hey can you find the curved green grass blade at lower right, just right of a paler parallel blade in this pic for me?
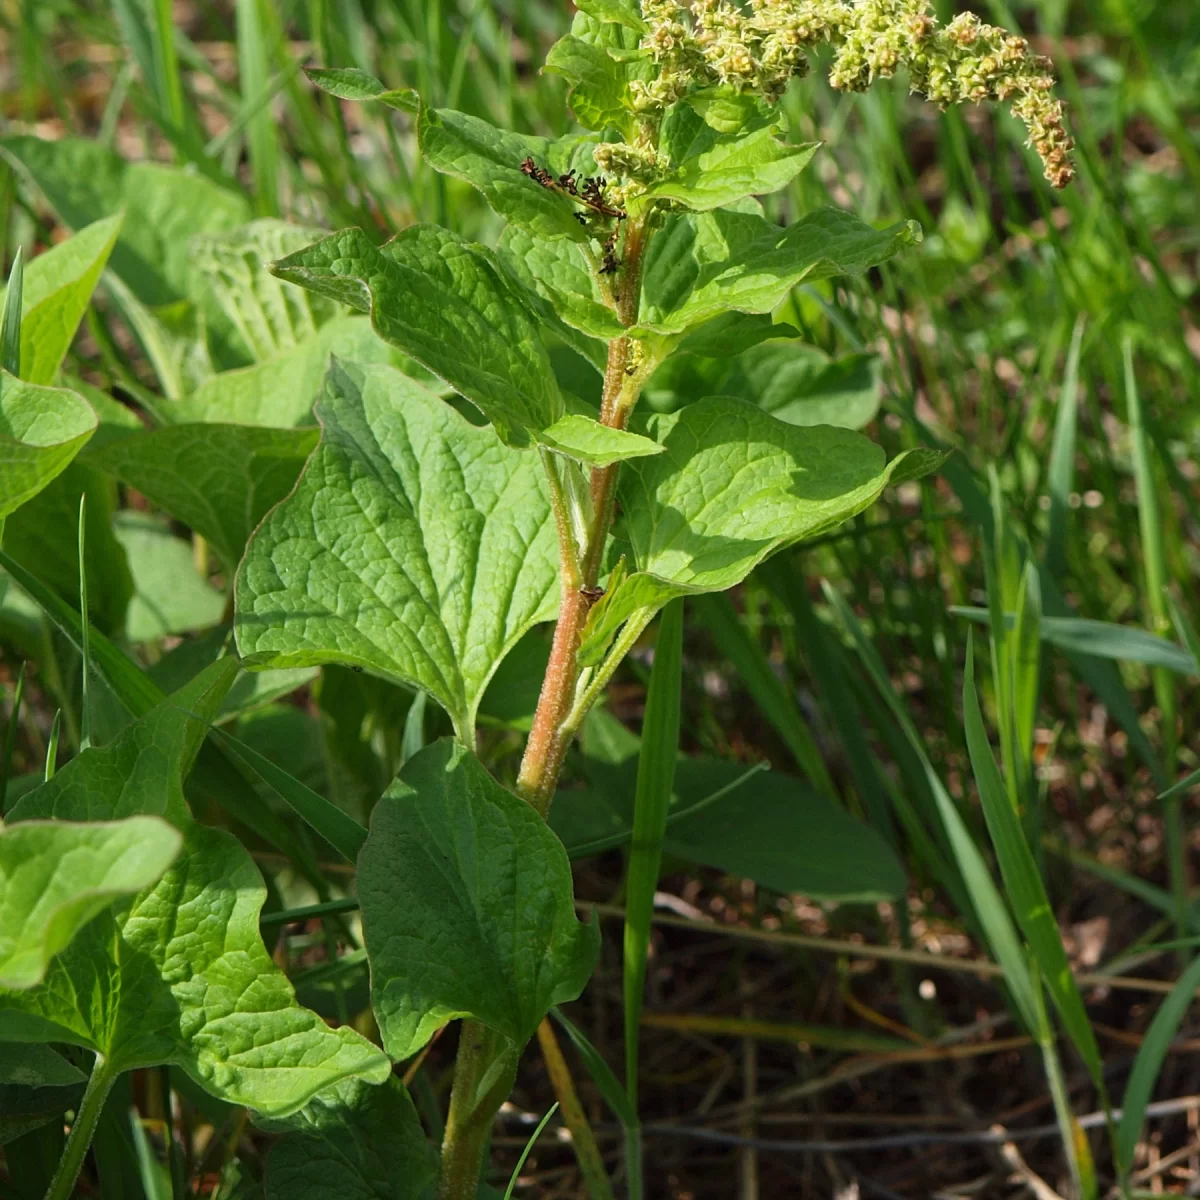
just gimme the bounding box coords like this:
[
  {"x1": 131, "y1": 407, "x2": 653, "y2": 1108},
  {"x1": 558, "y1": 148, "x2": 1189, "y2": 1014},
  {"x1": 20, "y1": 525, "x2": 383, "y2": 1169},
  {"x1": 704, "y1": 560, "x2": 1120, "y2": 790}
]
[{"x1": 962, "y1": 643, "x2": 1103, "y2": 1085}]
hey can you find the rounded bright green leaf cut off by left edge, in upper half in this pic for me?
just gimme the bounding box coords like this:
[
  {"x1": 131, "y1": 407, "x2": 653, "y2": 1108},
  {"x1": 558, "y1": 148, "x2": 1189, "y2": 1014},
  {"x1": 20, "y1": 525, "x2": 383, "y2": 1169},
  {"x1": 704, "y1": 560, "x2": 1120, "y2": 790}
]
[{"x1": 0, "y1": 371, "x2": 97, "y2": 521}]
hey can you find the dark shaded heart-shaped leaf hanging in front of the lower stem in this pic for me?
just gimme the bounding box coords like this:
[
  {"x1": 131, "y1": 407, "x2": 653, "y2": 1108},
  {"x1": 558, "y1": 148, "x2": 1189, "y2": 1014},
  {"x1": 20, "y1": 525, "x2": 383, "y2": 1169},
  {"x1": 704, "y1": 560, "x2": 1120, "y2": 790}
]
[{"x1": 359, "y1": 740, "x2": 600, "y2": 1060}]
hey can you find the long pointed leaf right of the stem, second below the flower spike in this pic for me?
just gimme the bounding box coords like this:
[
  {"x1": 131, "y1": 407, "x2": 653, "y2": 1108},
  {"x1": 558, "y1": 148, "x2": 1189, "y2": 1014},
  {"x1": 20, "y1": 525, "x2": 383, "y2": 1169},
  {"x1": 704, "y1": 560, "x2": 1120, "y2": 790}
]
[{"x1": 640, "y1": 209, "x2": 920, "y2": 334}]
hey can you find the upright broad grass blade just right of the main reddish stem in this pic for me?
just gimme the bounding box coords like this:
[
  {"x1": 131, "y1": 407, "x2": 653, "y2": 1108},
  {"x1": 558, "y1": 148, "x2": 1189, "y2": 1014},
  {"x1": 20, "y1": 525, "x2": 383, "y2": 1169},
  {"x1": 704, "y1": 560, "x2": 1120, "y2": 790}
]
[{"x1": 624, "y1": 600, "x2": 683, "y2": 1106}]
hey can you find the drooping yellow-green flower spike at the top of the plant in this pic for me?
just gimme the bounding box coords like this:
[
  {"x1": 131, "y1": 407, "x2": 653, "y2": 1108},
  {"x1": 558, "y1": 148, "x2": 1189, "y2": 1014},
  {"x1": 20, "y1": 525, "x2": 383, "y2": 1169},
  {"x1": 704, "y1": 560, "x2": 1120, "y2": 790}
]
[{"x1": 635, "y1": 0, "x2": 1074, "y2": 187}]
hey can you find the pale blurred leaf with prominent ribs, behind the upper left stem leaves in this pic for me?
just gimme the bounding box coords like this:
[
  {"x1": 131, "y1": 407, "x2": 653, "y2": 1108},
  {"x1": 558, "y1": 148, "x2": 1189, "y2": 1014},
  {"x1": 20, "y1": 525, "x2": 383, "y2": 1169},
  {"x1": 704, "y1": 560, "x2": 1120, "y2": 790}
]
[{"x1": 192, "y1": 221, "x2": 342, "y2": 362}]
